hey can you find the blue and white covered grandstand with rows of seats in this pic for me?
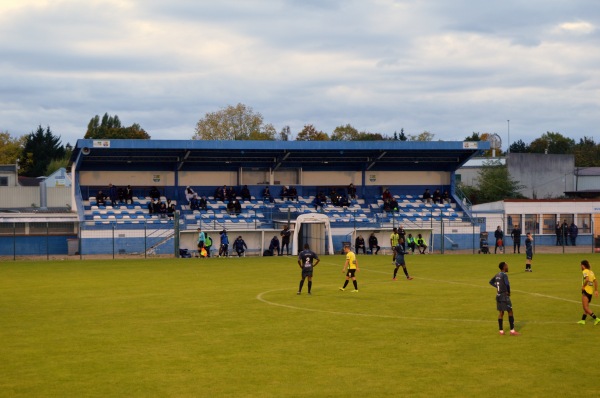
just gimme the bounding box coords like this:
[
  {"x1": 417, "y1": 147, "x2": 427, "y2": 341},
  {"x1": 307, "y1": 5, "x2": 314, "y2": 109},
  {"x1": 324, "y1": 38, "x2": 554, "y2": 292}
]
[{"x1": 58, "y1": 140, "x2": 489, "y2": 254}]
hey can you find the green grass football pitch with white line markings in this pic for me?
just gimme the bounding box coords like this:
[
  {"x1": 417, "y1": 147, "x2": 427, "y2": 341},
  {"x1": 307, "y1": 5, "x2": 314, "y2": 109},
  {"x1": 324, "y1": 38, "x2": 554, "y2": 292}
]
[{"x1": 0, "y1": 254, "x2": 600, "y2": 397}]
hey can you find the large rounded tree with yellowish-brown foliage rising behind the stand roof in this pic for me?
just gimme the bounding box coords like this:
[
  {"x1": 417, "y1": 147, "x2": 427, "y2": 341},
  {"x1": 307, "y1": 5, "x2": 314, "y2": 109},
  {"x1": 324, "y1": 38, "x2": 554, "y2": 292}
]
[{"x1": 192, "y1": 103, "x2": 268, "y2": 140}]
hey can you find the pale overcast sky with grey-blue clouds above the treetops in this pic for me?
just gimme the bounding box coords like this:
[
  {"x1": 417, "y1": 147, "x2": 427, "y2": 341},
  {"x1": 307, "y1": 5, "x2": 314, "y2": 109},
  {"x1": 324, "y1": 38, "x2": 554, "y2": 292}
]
[{"x1": 0, "y1": 0, "x2": 600, "y2": 148}]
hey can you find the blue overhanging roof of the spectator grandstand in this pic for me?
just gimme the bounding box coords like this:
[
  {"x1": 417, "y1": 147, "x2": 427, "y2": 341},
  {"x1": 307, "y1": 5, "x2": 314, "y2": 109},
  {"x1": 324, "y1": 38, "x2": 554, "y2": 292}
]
[{"x1": 72, "y1": 139, "x2": 490, "y2": 171}]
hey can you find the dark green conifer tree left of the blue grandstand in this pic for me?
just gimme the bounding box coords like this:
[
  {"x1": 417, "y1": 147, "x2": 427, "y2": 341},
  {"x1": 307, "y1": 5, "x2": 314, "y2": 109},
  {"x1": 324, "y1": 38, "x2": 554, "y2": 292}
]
[{"x1": 20, "y1": 126, "x2": 65, "y2": 177}]
